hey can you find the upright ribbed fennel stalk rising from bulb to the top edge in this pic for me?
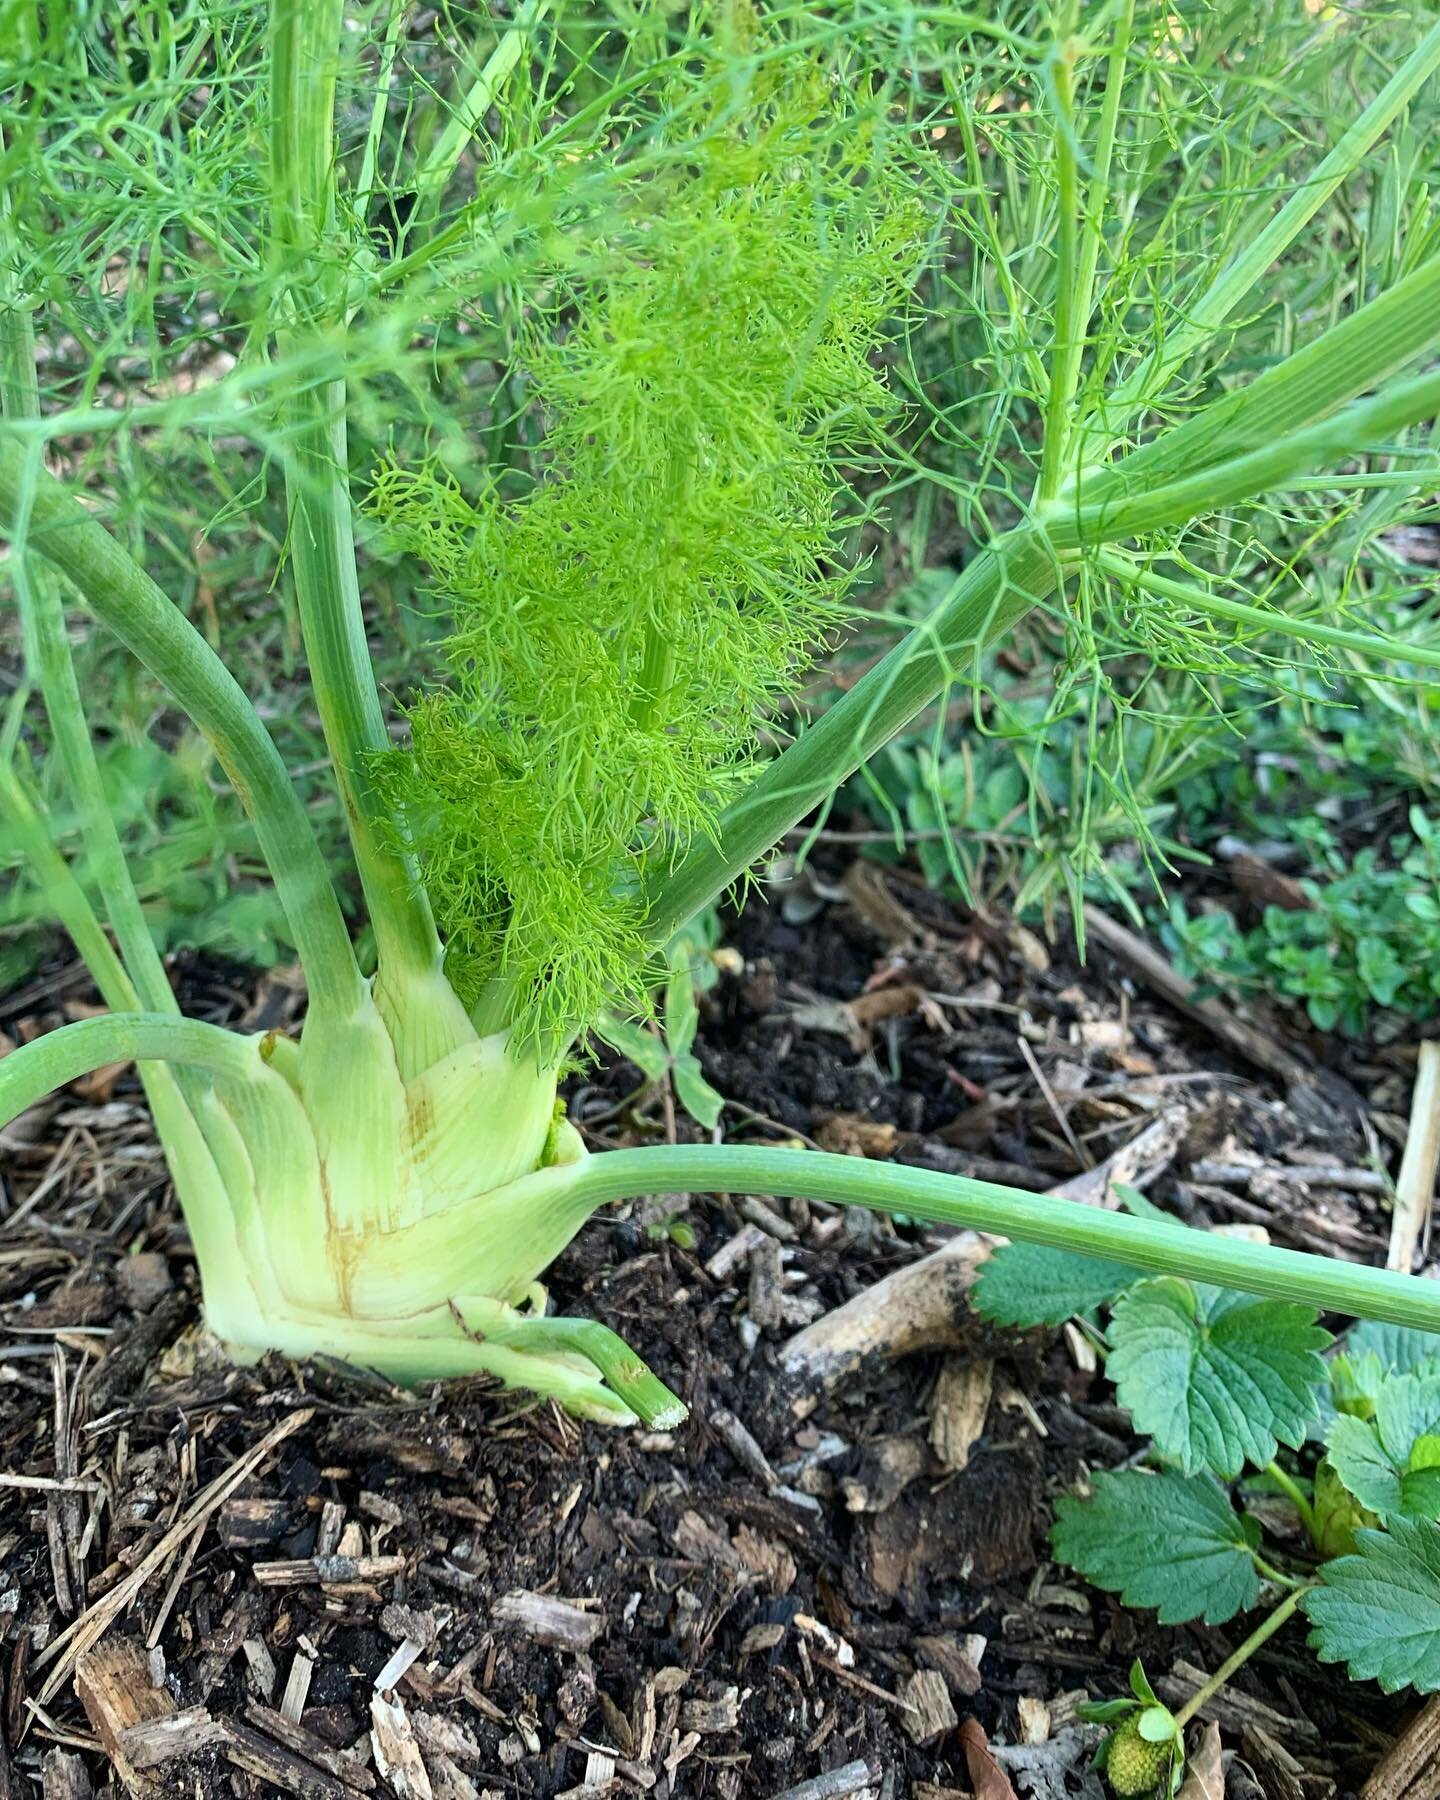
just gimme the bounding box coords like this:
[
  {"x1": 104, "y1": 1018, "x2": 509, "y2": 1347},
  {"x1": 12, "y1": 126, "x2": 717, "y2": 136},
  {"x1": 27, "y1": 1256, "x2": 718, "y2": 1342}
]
[{"x1": 270, "y1": 0, "x2": 441, "y2": 994}]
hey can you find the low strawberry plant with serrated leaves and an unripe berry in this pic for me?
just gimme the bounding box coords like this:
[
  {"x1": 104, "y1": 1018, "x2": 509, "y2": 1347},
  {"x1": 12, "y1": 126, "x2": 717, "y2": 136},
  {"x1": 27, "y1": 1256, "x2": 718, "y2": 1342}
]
[{"x1": 974, "y1": 1224, "x2": 1440, "y2": 1796}]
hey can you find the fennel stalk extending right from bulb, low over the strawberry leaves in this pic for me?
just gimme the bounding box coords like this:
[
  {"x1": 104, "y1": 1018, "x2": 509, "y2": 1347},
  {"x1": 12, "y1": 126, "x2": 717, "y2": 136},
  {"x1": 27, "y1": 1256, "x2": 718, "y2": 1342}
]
[{"x1": 576, "y1": 1145, "x2": 1440, "y2": 1332}]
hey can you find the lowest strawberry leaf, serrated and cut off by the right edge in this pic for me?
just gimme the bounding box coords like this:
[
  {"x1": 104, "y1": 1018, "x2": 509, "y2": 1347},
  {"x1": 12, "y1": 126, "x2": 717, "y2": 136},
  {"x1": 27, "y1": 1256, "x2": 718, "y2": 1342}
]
[{"x1": 1301, "y1": 1519, "x2": 1440, "y2": 1694}]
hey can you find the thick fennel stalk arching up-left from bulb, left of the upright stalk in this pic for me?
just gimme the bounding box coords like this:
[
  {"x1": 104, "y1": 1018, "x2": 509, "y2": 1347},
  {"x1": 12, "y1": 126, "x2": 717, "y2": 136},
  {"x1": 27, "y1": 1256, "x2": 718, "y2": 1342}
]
[{"x1": 0, "y1": 436, "x2": 364, "y2": 1015}]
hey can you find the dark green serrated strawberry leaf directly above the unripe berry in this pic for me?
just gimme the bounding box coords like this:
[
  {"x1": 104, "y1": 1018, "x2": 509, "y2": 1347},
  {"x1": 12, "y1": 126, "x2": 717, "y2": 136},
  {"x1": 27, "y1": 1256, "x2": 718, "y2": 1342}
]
[{"x1": 1049, "y1": 1469, "x2": 1260, "y2": 1625}]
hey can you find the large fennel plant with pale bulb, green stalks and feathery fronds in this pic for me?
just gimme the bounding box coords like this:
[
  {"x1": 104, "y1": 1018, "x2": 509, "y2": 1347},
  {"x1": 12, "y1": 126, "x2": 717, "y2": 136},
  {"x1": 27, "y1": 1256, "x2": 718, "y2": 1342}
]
[{"x1": 0, "y1": 0, "x2": 1440, "y2": 1422}]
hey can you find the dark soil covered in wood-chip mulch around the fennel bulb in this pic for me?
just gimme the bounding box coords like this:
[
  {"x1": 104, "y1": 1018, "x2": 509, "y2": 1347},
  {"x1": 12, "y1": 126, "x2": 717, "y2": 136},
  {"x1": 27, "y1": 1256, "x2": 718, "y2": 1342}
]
[{"x1": 0, "y1": 859, "x2": 1415, "y2": 1800}]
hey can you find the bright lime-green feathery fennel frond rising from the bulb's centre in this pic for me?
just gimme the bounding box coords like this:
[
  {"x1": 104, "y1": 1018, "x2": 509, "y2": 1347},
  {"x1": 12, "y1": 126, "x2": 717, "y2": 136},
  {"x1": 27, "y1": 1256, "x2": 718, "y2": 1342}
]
[{"x1": 367, "y1": 65, "x2": 927, "y2": 1044}]
